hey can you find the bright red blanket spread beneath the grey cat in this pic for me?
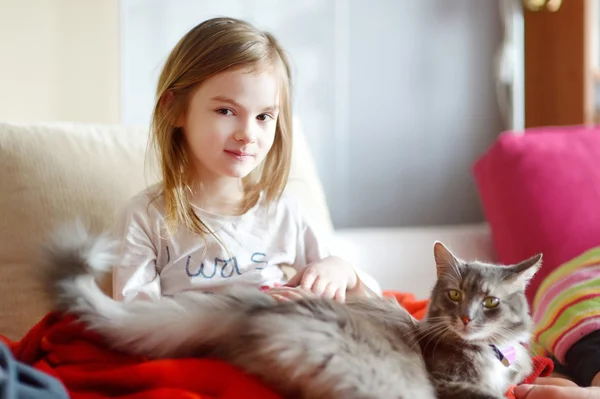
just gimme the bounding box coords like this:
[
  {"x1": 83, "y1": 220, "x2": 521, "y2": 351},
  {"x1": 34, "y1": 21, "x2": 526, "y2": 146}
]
[{"x1": 0, "y1": 292, "x2": 552, "y2": 399}]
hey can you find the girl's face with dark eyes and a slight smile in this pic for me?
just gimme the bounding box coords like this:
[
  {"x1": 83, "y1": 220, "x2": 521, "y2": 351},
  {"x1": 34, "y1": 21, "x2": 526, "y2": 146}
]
[{"x1": 180, "y1": 69, "x2": 279, "y2": 181}]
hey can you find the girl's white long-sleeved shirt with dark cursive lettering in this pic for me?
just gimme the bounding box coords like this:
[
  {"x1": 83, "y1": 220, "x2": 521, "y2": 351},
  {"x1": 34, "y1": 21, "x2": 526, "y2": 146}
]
[{"x1": 113, "y1": 185, "x2": 329, "y2": 300}]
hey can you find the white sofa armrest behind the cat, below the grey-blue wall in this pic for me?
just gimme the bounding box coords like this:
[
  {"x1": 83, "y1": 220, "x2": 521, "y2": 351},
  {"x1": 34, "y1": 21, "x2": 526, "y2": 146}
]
[{"x1": 334, "y1": 223, "x2": 495, "y2": 298}]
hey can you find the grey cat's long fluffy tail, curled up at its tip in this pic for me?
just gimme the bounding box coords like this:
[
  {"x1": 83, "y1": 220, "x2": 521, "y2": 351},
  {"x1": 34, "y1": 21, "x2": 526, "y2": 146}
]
[{"x1": 41, "y1": 223, "x2": 274, "y2": 358}]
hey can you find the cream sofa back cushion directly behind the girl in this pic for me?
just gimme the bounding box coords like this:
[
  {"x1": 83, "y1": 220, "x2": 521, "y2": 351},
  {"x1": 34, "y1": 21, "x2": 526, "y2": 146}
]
[{"x1": 0, "y1": 123, "x2": 333, "y2": 339}]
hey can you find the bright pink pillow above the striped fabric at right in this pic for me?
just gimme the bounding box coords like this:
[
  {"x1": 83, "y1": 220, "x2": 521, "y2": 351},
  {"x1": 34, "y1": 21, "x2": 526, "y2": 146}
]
[{"x1": 473, "y1": 126, "x2": 600, "y2": 302}]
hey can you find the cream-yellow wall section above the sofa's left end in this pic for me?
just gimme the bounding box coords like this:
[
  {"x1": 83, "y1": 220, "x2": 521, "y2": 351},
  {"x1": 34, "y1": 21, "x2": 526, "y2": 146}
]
[{"x1": 0, "y1": 0, "x2": 120, "y2": 123}]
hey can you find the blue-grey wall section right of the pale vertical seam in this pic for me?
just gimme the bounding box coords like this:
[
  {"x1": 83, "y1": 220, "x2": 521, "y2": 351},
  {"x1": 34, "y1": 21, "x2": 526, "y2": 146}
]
[{"x1": 347, "y1": 0, "x2": 502, "y2": 230}]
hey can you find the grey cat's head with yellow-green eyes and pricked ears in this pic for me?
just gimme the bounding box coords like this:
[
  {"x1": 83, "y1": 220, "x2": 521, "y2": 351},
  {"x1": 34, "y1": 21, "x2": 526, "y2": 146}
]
[{"x1": 427, "y1": 242, "x2": 542, "y2": 344}]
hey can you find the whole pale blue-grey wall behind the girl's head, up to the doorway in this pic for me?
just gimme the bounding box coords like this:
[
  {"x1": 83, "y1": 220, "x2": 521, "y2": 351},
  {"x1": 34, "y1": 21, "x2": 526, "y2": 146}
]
[{"x1": 121, "y1": 0, "x2": 503, "y2": 228}]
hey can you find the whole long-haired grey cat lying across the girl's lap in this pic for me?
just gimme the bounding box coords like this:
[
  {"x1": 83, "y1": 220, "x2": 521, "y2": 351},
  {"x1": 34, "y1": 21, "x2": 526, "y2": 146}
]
[{"x1": 43, "y1": 225, "x2": 541, "y2": 399}]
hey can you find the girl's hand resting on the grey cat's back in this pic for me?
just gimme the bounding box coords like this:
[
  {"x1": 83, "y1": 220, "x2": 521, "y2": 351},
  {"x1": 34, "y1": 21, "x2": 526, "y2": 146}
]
[{"x1": 286, "y1": 256, "x2": 358, "y2": 303}]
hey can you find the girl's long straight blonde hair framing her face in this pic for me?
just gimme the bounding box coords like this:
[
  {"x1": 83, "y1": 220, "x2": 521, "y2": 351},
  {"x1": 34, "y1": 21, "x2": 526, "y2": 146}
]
[{"x1": 151, "y1": 18, "x2": 292, "y2": 241}]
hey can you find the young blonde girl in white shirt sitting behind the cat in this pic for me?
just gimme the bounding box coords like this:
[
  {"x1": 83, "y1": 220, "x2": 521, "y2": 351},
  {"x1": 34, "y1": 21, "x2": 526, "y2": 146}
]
[{"x1": 113, "y1": 18, "x2": 366, "y2": 301}]
